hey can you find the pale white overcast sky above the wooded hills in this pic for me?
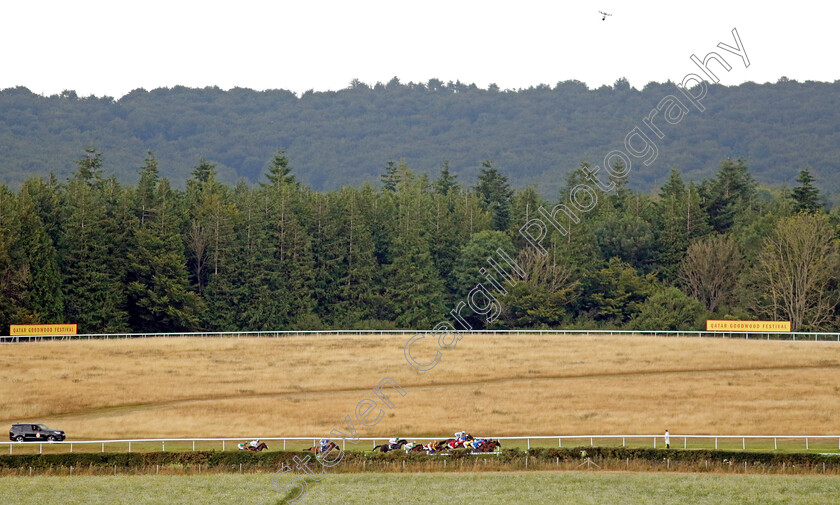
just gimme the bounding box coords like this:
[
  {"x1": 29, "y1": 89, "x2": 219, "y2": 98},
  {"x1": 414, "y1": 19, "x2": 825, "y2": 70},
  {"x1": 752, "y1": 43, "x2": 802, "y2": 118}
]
[{"x1": 0, "y1": 0, "x2": 840, "y2": 97}]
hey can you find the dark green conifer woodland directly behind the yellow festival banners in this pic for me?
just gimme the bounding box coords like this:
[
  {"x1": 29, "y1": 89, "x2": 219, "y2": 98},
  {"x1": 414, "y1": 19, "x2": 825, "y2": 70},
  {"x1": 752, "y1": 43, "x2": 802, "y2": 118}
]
[{"x1": 0, "y1": 149, "x2": 840, "y2": 333}]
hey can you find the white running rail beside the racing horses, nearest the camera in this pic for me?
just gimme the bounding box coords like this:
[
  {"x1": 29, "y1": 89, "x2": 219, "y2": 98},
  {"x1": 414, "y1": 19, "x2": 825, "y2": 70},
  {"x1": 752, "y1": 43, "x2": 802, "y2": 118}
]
[{"x1": 0, "y1": 434, "x2": 840, "y2": 454}]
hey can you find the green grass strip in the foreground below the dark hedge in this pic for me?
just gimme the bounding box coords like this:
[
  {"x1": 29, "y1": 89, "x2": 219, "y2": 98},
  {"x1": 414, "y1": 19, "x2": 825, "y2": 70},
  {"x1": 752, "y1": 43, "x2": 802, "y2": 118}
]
[{"x1": 0, "y1": 472, "x2": 840, "y2": 505}]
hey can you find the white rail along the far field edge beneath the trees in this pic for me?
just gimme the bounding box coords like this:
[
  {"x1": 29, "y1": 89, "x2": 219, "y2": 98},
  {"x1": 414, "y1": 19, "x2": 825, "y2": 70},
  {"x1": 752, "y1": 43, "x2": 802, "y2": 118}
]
[{"x1": 0, "y1": 330, "x2": 840, "y2": 343}]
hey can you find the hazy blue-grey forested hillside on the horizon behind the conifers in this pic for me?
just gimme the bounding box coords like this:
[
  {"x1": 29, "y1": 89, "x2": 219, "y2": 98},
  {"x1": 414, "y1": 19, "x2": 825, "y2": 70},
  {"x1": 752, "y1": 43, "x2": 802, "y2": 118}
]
[{"x1": 0, "y1": 78, "x2": 840, "y2": 202}]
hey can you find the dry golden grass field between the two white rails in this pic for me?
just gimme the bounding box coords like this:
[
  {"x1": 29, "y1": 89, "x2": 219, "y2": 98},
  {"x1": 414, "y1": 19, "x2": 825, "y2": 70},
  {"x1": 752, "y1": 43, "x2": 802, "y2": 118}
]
[{"x1": 0, "y1": 334, "x2": 840, "y2": 440}]
